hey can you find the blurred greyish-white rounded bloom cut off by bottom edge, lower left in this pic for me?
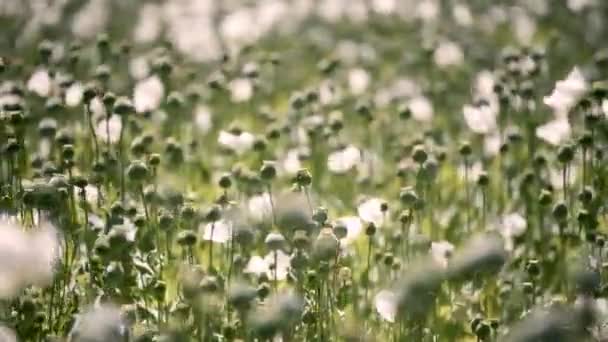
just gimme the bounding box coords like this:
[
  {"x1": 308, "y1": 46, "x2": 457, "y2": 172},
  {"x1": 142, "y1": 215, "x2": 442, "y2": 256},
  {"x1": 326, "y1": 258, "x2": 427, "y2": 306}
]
[{"x1": 68, "y1": 304, "x2": 129, "y2": 342}]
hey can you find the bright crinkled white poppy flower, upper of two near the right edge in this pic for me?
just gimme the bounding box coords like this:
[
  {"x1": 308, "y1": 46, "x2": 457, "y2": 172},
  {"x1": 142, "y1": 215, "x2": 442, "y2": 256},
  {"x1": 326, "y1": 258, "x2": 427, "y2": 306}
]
[{"x1": 543, "y1": 67, "x2": 588, "y2": 116}]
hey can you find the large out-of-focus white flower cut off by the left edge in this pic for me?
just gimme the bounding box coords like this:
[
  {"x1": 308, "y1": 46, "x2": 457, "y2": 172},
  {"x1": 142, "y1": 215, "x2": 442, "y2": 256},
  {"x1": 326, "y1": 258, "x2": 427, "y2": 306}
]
[{"x1": 0, "y1": 220, "x2": 61, "y2": 299}]
